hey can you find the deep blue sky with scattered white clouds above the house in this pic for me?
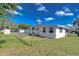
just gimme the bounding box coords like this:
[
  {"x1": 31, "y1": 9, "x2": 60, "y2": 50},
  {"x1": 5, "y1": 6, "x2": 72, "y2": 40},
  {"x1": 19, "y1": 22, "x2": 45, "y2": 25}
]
[{"x1": 9, "y1": 3, "x2": 79, "y2": 26}]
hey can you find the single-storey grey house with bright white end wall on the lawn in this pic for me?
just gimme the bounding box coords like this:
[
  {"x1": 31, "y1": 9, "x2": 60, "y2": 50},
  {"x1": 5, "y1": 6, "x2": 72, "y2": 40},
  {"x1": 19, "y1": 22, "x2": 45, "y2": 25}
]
[{"x1": 32, "y1": 25, "x2": 67, "y2": 38}]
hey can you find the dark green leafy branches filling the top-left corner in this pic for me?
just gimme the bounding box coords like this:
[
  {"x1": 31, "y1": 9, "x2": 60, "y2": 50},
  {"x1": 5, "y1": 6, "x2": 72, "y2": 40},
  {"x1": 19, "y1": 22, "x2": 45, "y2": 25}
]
[{"x1": 0, "y1": 3, "x2": 18, "y2": 16}]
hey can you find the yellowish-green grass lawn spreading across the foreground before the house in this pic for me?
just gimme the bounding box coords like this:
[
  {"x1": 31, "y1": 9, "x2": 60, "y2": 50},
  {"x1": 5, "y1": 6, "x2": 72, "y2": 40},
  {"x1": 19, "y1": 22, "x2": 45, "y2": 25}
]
[{"x1": 0, "y1": 34, "x2": 79, "y2": 56}]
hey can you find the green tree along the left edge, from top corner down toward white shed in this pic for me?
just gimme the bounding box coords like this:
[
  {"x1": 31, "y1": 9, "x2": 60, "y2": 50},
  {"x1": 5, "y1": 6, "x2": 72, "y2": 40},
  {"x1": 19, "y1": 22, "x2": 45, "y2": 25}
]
[{"x1": 0, "y1": 3, "x2": 18, "y2": 28}]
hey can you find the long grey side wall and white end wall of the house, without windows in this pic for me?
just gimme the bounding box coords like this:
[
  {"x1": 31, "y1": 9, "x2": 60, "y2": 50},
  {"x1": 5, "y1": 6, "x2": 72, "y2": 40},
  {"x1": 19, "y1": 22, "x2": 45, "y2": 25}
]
[{"x1": 33, "y1": 26, "x2": 67, "y2": 39}]
